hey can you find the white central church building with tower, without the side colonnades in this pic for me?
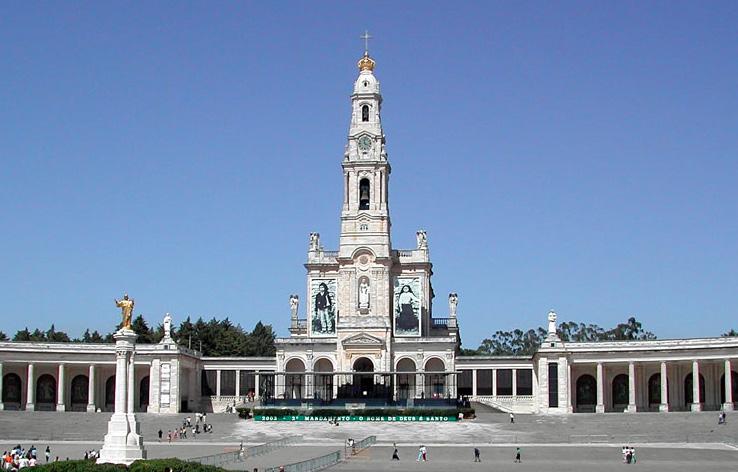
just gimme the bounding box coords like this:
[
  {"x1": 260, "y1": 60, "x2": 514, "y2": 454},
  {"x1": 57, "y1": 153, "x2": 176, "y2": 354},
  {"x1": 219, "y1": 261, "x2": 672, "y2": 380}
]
[{"x1": 274, "y1": 52, "x2": 459, "y2": 403}]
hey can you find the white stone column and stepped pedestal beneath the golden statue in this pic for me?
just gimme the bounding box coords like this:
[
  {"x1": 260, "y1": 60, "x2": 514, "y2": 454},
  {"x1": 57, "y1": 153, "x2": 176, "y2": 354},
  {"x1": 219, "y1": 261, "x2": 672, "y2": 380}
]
[{"x1": 97, "y1": 329, "x2": 146, "y2": 465}]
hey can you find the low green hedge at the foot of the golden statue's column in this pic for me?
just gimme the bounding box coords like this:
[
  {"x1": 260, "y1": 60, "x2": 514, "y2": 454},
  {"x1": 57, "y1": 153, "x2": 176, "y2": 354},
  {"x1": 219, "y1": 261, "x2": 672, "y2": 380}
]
[{"x1": 33, "y1": 459, "x2": 227, "y2": 472}]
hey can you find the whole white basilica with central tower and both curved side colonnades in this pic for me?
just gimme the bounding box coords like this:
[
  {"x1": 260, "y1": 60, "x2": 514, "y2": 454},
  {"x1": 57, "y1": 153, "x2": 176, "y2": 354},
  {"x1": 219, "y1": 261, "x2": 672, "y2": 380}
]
[{"x1": 0, "y1": 52, "x2": 738, "y2": 414}]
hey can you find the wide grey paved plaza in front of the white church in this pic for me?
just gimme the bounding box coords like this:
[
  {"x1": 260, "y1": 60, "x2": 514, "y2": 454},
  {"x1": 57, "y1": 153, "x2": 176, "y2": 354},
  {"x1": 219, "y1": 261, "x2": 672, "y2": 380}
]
[{"x1": 0, "y1": 411, "x2": 738, "y2": 471}]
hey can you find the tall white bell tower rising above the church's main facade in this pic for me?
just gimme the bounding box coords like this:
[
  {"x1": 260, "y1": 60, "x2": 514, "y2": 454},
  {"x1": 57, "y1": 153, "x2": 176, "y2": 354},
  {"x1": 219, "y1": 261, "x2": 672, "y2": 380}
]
[{"x1": 339, "y1": 51, "x2": 391, "y2": 258}]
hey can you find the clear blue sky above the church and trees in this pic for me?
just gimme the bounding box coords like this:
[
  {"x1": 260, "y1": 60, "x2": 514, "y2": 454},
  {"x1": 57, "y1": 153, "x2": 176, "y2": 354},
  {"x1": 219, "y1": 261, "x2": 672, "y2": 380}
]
[{"x1": 0, "y1": 1, "x2": 738, "y2": 347}]
